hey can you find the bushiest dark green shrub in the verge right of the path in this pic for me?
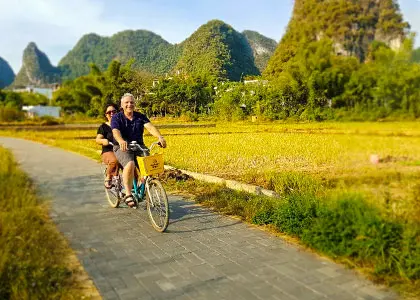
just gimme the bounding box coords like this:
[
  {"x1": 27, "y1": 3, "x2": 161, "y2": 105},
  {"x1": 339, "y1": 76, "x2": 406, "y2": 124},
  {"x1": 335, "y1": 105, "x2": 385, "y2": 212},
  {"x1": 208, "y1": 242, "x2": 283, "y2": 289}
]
[{"x1": 302, "y1": 194, "x2": 402, "y2": 259}]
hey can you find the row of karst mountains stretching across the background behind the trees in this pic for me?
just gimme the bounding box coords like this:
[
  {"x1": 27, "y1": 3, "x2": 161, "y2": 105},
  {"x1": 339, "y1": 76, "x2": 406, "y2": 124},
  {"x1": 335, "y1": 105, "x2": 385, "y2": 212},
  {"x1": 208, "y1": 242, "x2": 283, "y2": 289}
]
[{"x1": 7, "y1": 4, "x2": 420, "y2": 87}]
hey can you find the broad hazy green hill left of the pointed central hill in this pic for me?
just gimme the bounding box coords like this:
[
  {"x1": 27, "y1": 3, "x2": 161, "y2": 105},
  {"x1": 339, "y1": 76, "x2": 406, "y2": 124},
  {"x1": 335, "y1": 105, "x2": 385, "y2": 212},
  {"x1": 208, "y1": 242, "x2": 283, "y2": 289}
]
[{"x1": 59, "y1": 30, "x2": 182, "y2": 79}]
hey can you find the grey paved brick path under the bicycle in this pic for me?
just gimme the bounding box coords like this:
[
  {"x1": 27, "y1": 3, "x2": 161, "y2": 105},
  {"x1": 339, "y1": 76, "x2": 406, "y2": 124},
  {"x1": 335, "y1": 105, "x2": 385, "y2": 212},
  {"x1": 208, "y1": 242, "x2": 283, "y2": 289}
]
[{"x1": 0, "y1": 138, "x2": 397, "y2": 300}]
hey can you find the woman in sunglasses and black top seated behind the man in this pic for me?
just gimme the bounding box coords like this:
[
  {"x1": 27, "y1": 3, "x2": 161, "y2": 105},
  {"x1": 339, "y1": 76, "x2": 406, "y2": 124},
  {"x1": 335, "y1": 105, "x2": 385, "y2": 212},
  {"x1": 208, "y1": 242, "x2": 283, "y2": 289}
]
[{"x1": 96, "y1": 103, "x2": 118, "y2": 189}]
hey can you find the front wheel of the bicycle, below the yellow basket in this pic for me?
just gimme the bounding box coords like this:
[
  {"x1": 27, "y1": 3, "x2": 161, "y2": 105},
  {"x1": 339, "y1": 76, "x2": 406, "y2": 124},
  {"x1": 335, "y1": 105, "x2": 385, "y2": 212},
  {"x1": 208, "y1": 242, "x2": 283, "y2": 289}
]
[{"x1": 146, "y1": 179, "x2": 169, "y2": 232}]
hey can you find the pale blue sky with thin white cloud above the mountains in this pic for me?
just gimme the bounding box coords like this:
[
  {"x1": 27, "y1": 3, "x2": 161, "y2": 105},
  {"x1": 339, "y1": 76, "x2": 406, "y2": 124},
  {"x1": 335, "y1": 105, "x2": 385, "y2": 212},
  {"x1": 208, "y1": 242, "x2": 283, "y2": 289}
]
[{"x1": 0, "y1": 0, "x2": 420, "y2": 73}]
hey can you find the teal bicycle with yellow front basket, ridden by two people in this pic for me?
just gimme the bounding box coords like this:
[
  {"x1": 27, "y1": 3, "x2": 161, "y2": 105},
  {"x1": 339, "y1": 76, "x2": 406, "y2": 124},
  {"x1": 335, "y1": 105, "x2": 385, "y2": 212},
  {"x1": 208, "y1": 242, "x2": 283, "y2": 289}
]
[{"x1": 103, "y1": 142, "x2": 169, "y2": 232}]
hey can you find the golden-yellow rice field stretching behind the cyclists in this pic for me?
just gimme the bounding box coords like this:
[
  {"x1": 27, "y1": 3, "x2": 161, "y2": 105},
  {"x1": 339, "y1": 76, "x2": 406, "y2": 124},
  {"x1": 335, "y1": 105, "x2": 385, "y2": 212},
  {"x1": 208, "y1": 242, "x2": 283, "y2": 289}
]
[{"x1": 0, "y1": 122, "x2": 420, "y2": 221}]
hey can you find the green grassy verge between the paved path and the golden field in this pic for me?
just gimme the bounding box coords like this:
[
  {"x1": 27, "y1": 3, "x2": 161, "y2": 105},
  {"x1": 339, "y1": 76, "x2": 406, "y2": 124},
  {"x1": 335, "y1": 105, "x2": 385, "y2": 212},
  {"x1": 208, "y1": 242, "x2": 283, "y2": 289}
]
[{"x1": 164, "y1": 178, "x2": 420, "y2": 299}]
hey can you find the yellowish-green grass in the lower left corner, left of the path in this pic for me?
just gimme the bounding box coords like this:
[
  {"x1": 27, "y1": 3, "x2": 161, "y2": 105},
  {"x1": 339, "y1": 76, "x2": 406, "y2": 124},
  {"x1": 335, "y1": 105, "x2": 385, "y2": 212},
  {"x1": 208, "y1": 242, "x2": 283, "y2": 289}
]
[{"x1": 0, "y1": 147, "x2": 97, "y2": 299}]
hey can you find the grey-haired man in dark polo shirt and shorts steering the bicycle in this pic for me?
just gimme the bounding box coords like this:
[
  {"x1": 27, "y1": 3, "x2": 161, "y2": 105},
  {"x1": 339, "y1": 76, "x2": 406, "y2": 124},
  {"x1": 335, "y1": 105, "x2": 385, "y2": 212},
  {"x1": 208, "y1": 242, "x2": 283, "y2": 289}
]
[{"x1": 111, "y1": 93, "x2": 166, "y2": 207}]
